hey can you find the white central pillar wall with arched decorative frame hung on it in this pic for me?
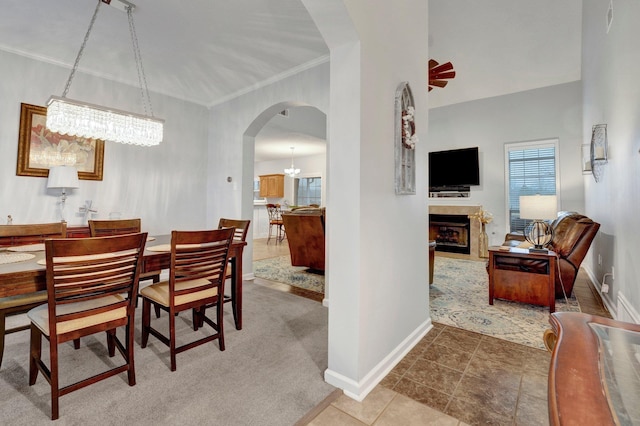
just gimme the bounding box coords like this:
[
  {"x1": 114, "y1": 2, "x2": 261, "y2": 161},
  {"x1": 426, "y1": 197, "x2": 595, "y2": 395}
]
[{"x1": 303, "y1": 0, "x2": 430, "y2": 399}]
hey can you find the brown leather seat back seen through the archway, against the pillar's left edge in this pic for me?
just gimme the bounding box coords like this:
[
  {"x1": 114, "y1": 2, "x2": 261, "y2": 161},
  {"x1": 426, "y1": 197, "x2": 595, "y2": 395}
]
[{"x1": 282, "y1": 207, "x2": 326, "y2": 272}]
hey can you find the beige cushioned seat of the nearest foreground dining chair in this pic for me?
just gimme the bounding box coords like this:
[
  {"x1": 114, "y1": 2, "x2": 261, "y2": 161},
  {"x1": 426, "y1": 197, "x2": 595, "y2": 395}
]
[{"x1": 27, "y1": 296, "x2": 127, "y2": 336}]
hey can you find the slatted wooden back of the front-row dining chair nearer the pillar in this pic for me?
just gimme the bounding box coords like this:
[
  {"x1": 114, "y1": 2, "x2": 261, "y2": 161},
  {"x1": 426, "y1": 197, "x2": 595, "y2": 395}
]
[{"x1": 169, "y1": 228, "x2": 235, "y2": 306}]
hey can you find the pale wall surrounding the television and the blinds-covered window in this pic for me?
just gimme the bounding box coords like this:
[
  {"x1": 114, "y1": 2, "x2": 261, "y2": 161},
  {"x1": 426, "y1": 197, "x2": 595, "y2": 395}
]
[{"x1": 428, "y1": 81, "x2": 585, "y2": 245}]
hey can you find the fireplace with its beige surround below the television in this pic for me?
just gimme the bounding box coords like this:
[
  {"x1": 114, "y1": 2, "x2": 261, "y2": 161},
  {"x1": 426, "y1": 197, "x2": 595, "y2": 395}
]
[{"x1": 429, "y1": 205, "x2": 482, "y2": 260}]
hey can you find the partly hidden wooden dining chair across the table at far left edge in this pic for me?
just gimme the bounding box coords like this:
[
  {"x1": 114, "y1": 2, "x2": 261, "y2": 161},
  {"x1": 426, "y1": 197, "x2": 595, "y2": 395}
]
[{"x1": 0, "y1": 222, "x2": 67, "y2": 366}]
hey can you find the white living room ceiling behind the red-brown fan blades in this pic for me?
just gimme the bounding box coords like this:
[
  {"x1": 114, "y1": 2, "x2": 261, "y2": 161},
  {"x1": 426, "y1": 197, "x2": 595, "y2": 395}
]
[{"x1": 428, "y1": 0, "x2": 584, "y2": 108}]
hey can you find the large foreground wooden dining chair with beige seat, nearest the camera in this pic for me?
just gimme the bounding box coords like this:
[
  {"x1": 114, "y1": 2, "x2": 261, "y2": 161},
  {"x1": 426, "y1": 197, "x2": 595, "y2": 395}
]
[{"x1": 27, "y1": 233, "x2": 147, "y2": 420}]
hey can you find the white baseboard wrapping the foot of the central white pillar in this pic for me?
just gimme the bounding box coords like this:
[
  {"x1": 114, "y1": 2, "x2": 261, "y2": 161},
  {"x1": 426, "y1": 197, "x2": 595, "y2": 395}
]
[{"x1": 324, "y1": 317, "x2": 433, "y2": 401}]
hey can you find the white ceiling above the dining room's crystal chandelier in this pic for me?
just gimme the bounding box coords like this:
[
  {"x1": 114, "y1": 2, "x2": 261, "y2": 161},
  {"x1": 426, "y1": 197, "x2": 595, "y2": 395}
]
[{"x1": 0, "y1": 0, "x2": 329, "y2": 106}]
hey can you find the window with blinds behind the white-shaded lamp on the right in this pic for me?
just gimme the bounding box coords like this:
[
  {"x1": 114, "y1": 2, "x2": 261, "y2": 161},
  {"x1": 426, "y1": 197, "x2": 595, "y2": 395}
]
[{"x1": 505, "y1": 139, "x2": 558, "y2": 232}]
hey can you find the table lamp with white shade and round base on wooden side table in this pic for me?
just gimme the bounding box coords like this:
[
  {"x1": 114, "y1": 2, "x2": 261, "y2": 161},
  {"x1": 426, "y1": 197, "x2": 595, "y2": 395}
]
[{"x1": 520, "y1": 194, "x2": 558, "y2": 253}]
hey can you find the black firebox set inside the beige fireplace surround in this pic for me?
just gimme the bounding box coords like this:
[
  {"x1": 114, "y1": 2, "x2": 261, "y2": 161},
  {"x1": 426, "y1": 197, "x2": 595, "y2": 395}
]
[{"x1": 429, "y1": 214, "x2": 471, "y2": 254}]
